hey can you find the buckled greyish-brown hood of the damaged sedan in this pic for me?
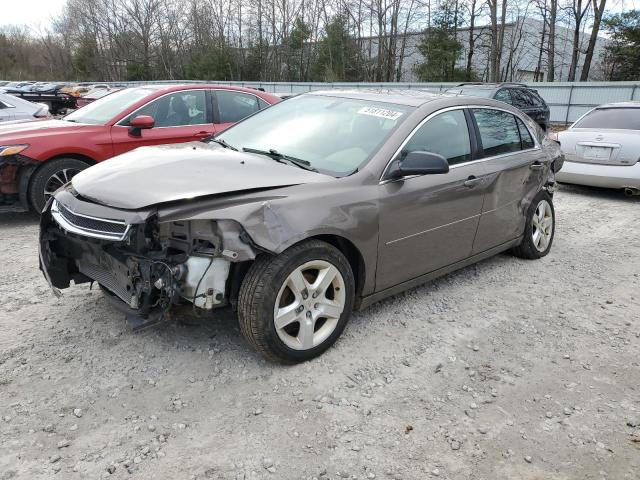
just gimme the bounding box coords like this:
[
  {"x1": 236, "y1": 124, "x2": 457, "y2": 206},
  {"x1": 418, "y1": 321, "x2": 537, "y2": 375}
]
[{"x1": 72, "y1": 142, "x2": 334, "y2": 210}]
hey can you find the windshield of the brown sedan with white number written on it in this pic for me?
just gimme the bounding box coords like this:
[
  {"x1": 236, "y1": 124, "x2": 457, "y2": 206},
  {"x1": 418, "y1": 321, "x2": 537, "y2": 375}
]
[{"x1": 216, "y1": 95, "x2": 413, "y2": 177}]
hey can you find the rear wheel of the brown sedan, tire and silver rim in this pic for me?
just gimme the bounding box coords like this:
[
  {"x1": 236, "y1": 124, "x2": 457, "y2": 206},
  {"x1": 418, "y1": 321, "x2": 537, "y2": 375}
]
[{"x1": 513, "y1": 190, "x2": 556, "y2": 260}]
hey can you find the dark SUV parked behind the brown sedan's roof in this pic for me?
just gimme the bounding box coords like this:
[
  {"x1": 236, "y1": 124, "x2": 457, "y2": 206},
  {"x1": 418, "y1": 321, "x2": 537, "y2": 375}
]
[{"x1": 447, "y1": 83, "x2": 549, "y2": 132}]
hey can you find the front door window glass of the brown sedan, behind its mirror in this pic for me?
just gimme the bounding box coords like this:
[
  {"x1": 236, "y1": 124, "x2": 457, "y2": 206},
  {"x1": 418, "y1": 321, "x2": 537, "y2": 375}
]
[{"x1": 402, "y1": 110, "x2": 471, "y2": 165}]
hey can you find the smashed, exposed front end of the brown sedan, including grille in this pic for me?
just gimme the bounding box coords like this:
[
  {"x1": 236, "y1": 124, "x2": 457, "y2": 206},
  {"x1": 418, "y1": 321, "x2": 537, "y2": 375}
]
[{"x1": 40, "y1": 193, "x2": 255, "y2": 328}]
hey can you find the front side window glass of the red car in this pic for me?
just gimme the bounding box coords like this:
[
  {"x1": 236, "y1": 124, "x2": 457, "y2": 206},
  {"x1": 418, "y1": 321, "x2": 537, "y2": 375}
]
[{"x1": 123, "y1": 90, "x2": 207, "y2": 127}]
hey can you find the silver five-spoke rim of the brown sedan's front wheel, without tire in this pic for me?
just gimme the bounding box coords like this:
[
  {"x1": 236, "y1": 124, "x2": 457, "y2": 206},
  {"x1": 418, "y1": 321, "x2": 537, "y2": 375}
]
[{"x1": 273, "y1": 260, "x2": 346, "y2": 350}]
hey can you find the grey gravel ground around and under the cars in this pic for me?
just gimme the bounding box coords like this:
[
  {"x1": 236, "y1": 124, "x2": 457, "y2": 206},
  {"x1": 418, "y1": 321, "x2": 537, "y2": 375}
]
[{"x1": 0, "y1": 187, "x2": 640, "y2": 480}]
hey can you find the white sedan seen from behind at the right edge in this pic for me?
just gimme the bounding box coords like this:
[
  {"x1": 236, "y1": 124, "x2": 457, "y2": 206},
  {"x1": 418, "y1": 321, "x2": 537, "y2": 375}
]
[{"x1": 550, "y1": 102, "x2": 640, "y2": 195}]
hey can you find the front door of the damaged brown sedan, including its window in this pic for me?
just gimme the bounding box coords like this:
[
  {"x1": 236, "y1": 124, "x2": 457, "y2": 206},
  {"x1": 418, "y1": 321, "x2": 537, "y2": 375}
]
[{"x1": 376, "y1": 108, "x2": 487, "y2": 290}]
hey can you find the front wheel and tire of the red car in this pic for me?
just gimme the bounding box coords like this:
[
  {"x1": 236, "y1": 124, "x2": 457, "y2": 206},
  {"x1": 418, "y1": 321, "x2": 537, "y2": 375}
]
[{"x1": 29, "y1": 158, "x2": 90, "y2": 213}]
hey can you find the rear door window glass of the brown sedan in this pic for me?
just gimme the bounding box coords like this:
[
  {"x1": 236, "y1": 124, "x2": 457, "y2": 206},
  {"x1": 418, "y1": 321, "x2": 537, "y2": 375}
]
[{"x1": 473, "y1": 108, "x2": 522, "y2": 157}]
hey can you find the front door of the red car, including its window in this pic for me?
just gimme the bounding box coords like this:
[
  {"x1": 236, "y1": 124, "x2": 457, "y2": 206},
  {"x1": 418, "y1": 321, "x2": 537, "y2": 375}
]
[{"x1": 111, "y1": 89, "x2": 215, "y2": 155}]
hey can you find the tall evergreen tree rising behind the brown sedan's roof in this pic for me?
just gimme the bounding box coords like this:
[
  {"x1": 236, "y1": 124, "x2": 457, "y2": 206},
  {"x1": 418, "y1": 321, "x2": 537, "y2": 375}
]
[{"x1": 414, "y1": 2, "x2": 471, "y2": 82}]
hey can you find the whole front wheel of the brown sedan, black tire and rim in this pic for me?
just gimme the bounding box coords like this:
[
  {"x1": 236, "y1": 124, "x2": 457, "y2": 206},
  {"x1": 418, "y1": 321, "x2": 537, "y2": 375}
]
[{"x1": 238, "y1": 240, "x2": 355, "y2": 363}]
